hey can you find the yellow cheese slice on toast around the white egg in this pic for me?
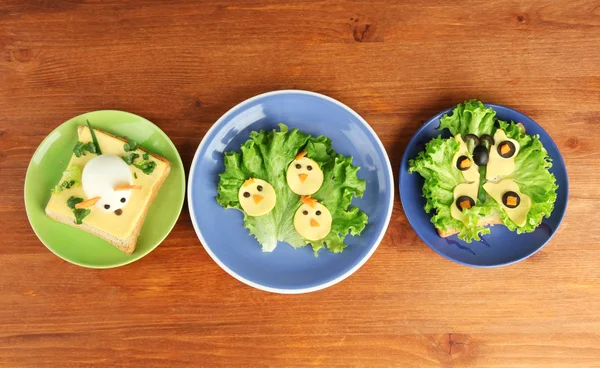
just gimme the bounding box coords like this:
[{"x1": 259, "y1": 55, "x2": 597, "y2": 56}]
[{"x1": 48, "y1": 127, "x2": 167, "y2": 238}]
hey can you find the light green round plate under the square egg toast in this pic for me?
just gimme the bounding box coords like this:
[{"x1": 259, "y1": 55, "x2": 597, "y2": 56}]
[{"x1": 25, "y1": 110, "x2": 185, "y2": 268}]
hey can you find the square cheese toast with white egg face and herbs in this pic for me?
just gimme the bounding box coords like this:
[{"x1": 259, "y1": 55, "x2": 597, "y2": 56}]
[{"x1": 46, "y1": 122, "x2": 170, "y2": 254}]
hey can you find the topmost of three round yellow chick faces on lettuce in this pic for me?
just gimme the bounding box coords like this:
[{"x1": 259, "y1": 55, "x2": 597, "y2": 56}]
[{"x1": 286, "y1": 152, "x2": 323, "y2": 195}]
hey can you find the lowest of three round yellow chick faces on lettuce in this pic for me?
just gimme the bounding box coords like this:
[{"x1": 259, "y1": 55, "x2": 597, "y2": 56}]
[{"x1": 294, "y1": 196, "x2": 332, "y2": 240}]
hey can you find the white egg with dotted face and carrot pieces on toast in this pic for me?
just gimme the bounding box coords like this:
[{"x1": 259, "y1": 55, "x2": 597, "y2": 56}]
[{"x1": 75, "y1": 154, "x2": 141, "y2": 215}]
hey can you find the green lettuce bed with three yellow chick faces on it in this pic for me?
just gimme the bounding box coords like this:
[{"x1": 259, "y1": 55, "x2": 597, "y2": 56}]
[{"x1": 216, "y1": 124, "x2": 368, "y2": 255}]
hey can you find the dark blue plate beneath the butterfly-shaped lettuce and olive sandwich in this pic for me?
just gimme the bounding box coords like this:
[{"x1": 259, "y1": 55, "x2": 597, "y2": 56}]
[{"x1": 400, "y1": 104, "x2": 569, "y2": 267}]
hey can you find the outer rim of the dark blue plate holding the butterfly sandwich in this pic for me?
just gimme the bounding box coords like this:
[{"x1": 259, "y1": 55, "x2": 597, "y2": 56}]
[{"x1": 398, "y1": 102, "x2": 569, "y2": 268}]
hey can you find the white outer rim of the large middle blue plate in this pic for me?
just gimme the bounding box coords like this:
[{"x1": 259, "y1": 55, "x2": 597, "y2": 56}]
[{"x1": 187, "y1": 89, "x2": 396, "y2": 294}]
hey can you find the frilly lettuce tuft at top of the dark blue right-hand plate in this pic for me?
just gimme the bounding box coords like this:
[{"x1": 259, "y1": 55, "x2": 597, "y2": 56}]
[{"x1": 439, "y1": 100, "x2": 496, "y2": 137}]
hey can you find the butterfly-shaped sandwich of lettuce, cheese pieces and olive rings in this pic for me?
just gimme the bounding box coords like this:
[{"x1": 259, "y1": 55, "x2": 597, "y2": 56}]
[{"x1": 409, "y1": 100, "x2": 558, "y2": 242}]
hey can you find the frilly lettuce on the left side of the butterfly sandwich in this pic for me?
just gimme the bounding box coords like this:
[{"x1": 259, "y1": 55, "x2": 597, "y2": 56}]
[{"x1": 408, "y1": 136, "x2": 496, "y2": 243}]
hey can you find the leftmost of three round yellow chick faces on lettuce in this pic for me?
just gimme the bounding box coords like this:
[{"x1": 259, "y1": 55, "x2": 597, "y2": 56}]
[{"x1": 238, "y1": 178, "x2": 277, "y2": 216}]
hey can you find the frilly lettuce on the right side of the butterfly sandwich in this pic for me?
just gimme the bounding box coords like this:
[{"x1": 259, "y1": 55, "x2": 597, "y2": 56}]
[{"x1": 489, "y1": 120, "x2": 558, "y2": 234}]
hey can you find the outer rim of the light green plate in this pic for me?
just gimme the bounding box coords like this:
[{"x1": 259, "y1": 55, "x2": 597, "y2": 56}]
[{"x1": 23, "y1": 109, "x2": 187, "y2": 269}]
